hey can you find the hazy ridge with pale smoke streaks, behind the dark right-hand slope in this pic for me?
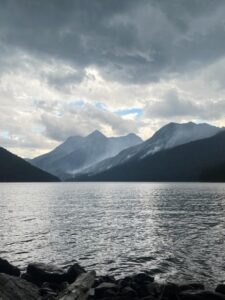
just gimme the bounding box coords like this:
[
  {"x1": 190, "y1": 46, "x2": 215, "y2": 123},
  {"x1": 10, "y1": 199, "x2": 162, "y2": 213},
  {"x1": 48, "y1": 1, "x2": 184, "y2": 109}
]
[{"x1": 75, "y1": 122, "x2": 221, "y2": 177}]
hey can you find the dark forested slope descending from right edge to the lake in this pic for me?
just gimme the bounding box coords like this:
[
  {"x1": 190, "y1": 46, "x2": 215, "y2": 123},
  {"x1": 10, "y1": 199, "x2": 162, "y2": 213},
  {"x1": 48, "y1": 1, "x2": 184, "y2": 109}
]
[{"x1": 76, "y1": 130, "x2": 225, "y2": 181}]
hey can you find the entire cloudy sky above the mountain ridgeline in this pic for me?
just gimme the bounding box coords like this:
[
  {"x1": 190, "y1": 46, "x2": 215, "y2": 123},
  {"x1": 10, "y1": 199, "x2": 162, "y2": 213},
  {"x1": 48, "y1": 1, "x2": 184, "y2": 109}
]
[{"x1": 0, "y1": 0, "x2": 225, "y2": 157}]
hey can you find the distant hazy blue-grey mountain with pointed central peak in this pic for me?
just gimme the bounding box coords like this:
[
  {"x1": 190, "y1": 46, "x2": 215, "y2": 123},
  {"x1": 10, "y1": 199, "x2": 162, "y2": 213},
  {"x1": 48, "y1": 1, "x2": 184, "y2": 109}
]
[{"x1": 31, "y1": 130, "x2": 142, "y2": 178}]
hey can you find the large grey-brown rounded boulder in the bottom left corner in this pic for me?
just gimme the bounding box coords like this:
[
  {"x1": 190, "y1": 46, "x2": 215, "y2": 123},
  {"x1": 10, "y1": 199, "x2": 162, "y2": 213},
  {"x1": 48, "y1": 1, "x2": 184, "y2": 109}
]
[{"x1": 0, "y1": 274, "x2": 40, "y2": 300}]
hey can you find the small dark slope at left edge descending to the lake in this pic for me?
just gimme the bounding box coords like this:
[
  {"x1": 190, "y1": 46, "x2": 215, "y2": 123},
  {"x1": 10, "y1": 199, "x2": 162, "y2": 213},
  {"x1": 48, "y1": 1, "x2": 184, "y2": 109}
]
[{"x1": 0, "y1": 147, "x2": 59, "y2": 182}]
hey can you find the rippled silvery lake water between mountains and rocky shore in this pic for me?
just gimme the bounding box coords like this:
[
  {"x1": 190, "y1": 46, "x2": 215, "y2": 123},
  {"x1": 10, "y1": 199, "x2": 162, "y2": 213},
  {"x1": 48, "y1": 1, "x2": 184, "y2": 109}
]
[{"x1": 0, "y1": 183, "x2": 225, "y2": 285}]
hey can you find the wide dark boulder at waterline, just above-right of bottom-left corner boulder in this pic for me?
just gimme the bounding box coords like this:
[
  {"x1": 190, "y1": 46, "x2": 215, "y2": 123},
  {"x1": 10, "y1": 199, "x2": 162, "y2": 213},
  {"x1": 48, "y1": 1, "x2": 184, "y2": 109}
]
[{"x1": 26, "y1": 263, "x2": 66, "y2": 285}]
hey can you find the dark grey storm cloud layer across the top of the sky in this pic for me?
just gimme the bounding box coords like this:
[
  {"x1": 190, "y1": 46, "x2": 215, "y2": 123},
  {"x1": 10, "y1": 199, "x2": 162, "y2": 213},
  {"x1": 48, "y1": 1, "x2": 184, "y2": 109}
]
[{"x1": 0, "y1": 0, "x2": 225, "y2": 85}]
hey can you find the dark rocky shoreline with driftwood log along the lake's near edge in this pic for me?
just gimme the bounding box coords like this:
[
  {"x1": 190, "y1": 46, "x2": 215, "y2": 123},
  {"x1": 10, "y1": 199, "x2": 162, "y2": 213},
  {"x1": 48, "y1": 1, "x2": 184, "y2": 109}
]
[{"x1": 0, "y1": 258, "x2": 225, "y2": 300}]
